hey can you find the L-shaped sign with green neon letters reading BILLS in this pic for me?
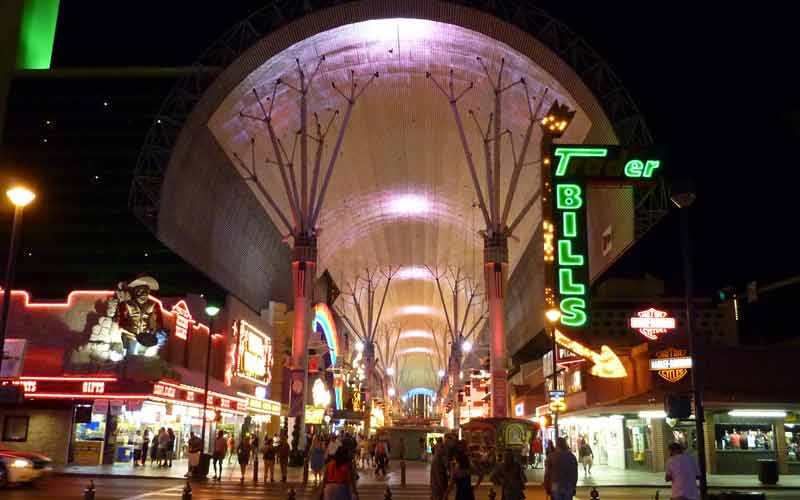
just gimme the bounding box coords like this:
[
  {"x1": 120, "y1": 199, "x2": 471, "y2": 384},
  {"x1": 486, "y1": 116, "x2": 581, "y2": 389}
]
[{"x1": 550, "y1": 144, "x2": 663, "y2": 328}]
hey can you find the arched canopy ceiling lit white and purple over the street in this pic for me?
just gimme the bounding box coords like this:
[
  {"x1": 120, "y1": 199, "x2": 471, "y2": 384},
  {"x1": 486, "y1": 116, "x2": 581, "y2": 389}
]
[{"x1": 152, "y1": 5, "x2": 615, "y2": 394}]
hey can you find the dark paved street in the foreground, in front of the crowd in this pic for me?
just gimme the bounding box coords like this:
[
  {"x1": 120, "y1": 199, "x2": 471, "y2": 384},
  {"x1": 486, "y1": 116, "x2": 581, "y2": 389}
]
[{"x1": 6, "y1": 477, "x2": 800, "y2": 500}]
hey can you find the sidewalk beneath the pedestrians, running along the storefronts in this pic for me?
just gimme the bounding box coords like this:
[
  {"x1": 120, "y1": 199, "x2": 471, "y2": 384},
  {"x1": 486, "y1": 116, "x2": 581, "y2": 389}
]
[{"x1": 55, "y1": 459, "x2": 800, "y2": 490}]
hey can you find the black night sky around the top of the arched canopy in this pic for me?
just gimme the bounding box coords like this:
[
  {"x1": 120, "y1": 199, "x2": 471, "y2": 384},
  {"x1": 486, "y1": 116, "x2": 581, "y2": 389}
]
[{"x1": 0, "y1": 0, "x2": 800, "y2": 300}]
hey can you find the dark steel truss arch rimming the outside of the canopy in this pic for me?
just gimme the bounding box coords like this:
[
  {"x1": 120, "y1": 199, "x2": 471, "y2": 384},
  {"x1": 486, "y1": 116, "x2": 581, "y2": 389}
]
[{"x1": 129, "y1": 0, "x2": 668, "y2": 238}]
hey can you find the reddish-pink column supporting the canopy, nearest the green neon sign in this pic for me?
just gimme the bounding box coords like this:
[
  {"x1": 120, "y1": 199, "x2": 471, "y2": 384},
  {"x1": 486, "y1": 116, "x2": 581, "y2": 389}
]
[{"x1": 483, "y1": 234, "x2": 508, "y2": 417}]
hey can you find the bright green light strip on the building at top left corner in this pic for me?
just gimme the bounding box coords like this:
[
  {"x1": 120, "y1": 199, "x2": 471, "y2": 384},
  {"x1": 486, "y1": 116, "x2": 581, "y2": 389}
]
[{"x1": 17, "y1": 0, "x2": 59, "y2": 69}]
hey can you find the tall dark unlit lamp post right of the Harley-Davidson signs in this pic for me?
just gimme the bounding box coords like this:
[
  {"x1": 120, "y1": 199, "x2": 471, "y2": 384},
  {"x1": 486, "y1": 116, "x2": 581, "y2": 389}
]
[{"x1": 670, "y1": 181, "x2": 708, "y2": 500}]
